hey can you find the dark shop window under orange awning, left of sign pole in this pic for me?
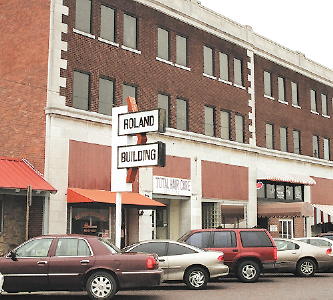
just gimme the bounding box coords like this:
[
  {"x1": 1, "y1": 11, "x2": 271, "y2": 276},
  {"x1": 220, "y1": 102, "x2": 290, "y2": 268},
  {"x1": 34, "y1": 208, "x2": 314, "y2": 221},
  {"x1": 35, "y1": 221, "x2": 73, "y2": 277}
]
[{"x1": 72, "y1": 207, "x2": 110, "y2": 237}]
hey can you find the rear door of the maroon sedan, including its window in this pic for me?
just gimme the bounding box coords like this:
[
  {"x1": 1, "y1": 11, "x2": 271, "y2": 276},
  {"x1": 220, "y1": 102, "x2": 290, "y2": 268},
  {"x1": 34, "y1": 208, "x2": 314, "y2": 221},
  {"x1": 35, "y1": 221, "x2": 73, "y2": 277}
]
[{"x1": 49, "y1": 237, "x2": 95, "y2": 290}]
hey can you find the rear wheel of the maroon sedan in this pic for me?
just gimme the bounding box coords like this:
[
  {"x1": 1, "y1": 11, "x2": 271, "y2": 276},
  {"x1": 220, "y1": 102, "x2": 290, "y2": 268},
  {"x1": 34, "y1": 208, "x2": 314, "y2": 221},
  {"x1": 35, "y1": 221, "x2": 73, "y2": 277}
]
[{"x1": 86, "y1": 271, "x2": 118, "y2": 300}]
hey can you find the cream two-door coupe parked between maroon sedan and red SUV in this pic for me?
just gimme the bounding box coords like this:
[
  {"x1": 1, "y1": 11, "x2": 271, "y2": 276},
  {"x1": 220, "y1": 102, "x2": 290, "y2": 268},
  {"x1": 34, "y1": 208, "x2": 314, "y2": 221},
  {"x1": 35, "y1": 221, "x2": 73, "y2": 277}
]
[{"x1": 123, "y1": 240, "x2": 229, "y2": 289}]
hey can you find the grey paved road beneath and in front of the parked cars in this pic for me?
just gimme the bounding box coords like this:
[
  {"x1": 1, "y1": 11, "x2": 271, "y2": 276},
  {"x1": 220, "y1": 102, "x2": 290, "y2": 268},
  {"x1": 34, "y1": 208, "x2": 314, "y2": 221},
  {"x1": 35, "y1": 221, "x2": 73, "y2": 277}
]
[{"x1": 1, "y1": 273, "x2": 333, "y2": 300}]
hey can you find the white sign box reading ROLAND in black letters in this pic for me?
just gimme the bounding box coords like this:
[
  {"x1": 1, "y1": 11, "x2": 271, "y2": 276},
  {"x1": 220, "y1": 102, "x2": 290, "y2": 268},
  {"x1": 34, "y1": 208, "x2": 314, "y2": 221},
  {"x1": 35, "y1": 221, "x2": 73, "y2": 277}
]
[{"x1": 118, "y1": 109, "x2": 165, "y2": 135}]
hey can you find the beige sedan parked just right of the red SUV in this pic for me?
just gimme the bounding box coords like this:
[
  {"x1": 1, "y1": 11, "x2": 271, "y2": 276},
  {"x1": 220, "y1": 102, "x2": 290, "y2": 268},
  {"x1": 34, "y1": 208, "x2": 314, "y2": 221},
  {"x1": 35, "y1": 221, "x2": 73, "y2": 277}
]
[{"x1": 274, "y1": 238, "x2": 332, "y2": 277}]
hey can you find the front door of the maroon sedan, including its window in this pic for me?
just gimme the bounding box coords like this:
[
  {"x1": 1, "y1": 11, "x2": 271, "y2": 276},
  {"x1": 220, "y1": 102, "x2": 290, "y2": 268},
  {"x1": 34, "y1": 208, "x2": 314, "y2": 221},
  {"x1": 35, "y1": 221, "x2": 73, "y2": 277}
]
[{"x1": 1, "y1": 238, "x2": 53, "y2": 291}]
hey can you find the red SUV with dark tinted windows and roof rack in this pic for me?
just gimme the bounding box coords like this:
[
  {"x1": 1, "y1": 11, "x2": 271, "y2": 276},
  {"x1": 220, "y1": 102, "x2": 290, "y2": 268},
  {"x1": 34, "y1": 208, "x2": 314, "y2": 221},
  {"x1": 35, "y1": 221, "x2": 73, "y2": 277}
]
[{"x1": 178, "y1": 228, "x2": 277, "y2": 282}]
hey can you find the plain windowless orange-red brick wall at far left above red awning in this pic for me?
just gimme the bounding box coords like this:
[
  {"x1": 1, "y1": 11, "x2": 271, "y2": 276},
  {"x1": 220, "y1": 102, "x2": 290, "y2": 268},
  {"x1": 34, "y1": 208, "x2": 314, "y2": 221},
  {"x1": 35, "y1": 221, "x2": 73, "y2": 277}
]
[{"x1": 0, "y1": 0, "x2": 50, "y2": 172}]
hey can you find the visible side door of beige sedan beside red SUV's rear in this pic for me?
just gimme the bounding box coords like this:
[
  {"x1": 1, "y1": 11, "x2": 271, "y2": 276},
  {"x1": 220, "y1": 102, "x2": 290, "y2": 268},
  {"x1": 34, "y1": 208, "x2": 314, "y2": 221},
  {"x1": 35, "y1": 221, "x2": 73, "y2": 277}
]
[{"x1": 275, "y1": 240, "x2": 301, "y2": 271}]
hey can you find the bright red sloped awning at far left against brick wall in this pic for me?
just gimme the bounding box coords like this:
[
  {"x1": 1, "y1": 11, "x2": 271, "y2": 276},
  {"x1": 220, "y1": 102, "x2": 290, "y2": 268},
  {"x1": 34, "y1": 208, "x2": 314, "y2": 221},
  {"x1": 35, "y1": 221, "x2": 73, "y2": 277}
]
[{"x1": 0, "y1": 157, "x2": 56, "y2": 192}]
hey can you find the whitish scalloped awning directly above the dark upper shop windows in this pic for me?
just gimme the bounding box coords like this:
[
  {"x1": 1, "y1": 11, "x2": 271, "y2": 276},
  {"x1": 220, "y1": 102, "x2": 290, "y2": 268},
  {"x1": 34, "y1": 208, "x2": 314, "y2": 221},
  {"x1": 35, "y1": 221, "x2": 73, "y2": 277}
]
[{"x1": 257, "y1": 169, "x2": 316, "y2": 185}]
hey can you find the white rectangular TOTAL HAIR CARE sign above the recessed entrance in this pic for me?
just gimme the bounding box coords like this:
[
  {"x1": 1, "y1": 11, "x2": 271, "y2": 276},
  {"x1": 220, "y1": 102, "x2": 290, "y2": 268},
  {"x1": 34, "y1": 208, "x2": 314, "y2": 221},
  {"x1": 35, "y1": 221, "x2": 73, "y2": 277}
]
[{"x1": 153, "y1": 176, "x2": 192, "y2": 196}]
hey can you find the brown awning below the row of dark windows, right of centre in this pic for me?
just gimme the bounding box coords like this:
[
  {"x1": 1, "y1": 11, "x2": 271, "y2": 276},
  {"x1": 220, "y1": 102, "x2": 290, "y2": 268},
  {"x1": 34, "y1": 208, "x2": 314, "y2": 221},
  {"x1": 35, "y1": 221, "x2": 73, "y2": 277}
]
[{"x1": 258, "y1": 202, "x2": 313, "y2": 217}]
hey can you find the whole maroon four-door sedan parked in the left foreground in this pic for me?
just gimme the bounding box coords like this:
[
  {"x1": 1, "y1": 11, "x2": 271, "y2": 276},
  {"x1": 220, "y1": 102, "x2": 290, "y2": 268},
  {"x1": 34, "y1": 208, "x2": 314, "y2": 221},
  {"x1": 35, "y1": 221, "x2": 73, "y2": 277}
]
[{"x1": 0, "y1": 235, "x2": 162, "y2": 299}]
